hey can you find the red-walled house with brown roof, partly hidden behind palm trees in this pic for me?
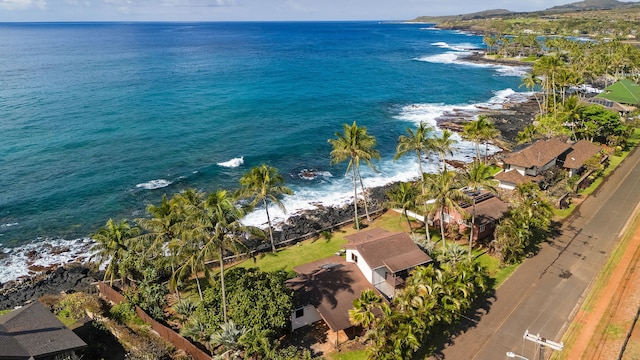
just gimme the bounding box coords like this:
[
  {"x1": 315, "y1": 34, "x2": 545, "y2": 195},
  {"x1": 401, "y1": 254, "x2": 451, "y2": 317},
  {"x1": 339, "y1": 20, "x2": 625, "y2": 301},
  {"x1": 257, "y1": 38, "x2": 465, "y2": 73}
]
[{"x1": 435, "y1": 191, "x2": 510, "y2": 241}]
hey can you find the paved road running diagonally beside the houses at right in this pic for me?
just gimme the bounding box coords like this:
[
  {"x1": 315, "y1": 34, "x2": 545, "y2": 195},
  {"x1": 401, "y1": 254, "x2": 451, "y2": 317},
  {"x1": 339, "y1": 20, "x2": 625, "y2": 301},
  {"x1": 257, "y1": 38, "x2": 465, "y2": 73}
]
[{"x1": 437, "y1": 147, "x2": 640, "y2": 360}]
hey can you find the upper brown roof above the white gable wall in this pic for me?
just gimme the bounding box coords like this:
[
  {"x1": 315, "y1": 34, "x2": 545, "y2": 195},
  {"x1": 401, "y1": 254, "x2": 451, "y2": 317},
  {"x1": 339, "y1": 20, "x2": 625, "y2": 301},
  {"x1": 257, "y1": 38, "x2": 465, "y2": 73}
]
[{"x1": 346, "y1": 229, "x2": 431, "y2": 273}]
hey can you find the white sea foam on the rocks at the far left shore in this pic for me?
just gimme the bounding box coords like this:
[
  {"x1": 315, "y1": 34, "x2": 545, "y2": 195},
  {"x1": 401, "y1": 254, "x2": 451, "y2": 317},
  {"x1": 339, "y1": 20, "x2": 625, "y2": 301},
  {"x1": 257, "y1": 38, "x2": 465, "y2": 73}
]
[{"x1": 0, "y1": 238, "x2": 95, "y2": 283}]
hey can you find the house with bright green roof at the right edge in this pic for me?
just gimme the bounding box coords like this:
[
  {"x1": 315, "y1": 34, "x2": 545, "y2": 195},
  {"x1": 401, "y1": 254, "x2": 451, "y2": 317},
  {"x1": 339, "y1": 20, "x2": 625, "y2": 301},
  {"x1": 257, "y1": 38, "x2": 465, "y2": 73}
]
[{"x1": 586, "y1": 79, "x2": 640, "y2": 115}]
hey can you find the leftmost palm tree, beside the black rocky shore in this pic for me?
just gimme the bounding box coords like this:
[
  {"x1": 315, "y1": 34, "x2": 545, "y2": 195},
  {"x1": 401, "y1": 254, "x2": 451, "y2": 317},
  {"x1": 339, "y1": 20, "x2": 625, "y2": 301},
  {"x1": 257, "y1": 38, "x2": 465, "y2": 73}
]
[{"x1": 92, "y1": 219, "x2": 140, "y2": 286}]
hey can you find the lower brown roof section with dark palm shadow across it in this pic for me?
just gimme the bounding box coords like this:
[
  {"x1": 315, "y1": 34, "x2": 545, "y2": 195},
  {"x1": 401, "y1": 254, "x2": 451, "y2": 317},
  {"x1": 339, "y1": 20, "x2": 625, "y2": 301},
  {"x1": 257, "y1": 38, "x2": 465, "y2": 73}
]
[{"x1": 287, "y1": 256, "x2": 376, "y2": 331}]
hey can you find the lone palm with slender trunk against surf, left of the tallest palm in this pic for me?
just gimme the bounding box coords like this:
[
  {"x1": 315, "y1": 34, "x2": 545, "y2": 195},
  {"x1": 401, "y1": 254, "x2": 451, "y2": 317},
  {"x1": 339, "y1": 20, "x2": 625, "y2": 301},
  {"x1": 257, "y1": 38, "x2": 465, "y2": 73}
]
[{"x1": 240, "y1": 164, "x2": 293, "y2": 253}]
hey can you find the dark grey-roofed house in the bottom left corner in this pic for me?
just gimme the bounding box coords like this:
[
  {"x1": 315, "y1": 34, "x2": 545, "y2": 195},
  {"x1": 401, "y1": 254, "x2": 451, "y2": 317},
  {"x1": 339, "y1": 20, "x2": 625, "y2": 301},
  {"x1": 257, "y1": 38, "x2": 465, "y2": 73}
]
[{"x1": 0, "y1": 301, "x2": 87, "y2": 360}]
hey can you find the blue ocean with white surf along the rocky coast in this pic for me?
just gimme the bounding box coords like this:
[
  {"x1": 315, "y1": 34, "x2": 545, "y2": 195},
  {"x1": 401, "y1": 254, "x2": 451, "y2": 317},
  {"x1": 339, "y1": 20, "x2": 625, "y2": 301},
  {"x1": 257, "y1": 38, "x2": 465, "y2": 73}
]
[{"x1": 0, "y1": 22, "x2": 527, "y2": 282}]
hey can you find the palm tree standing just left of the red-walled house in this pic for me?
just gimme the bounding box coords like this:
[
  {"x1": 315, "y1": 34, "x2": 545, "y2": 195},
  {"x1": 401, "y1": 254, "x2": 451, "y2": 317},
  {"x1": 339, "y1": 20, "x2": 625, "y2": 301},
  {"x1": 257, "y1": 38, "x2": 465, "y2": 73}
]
[{"x1": 423, "y1": 170, "x2": 468, "y2": 249}]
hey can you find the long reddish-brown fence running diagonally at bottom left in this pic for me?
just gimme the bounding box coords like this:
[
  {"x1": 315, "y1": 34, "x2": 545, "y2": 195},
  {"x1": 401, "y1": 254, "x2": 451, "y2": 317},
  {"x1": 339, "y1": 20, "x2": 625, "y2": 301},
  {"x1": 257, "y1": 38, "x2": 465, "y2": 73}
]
[{"x1": 98, "y1": 281, "x2": 211, "y2": 360}]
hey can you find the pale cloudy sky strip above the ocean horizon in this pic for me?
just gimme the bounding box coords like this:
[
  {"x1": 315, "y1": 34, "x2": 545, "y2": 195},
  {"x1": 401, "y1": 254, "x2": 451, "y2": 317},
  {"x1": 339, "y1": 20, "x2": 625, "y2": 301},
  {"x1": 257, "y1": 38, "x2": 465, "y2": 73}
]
[{"x1": 0, "y1": 0, "x2": 636, "y2": 22}]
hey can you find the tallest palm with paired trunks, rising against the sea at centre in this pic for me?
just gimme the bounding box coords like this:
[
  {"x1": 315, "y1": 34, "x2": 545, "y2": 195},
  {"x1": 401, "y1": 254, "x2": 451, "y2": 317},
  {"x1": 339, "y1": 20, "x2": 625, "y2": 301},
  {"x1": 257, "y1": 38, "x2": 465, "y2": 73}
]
[{"x1": 329, "y1": 121, "x2": 380, "y2": 230}]
